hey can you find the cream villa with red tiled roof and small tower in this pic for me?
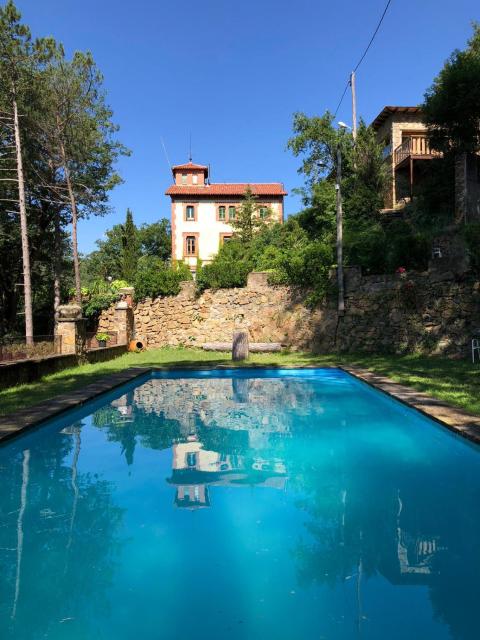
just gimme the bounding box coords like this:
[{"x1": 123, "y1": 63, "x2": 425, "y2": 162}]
[{"x1": 165, "y1": 162, "x2": 287, "y2": 271}]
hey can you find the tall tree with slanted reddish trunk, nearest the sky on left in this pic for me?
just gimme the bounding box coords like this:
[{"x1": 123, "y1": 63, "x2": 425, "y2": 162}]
[{"x1": 38, "y1": 45, "x2": 128, "y2": 303}]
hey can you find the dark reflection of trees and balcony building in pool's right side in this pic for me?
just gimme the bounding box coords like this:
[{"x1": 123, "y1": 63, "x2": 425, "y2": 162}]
[{"x1": 287, "y1": 440, "x2": 480, "y2": 640}]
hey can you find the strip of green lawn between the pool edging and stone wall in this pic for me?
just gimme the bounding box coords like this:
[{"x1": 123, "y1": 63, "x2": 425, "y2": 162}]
[{"x1": 0, "y1": 349, "x2": 480, "y2": 415}]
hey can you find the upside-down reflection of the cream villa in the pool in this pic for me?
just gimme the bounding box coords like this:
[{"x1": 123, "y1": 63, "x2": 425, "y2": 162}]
[{"x1": 168, "y1": 437, "x2": 287, "y2": 509}]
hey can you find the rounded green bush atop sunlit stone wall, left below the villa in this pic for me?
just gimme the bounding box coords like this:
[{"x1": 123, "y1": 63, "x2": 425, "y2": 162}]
[{"x1": 134, "y1": 256, "x2": 192, "y2": 300}]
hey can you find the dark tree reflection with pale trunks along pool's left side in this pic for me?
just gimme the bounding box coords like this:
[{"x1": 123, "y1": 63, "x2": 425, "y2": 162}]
[{"x1": 0, "y1": 424, "x2": 122, "y2": 640}]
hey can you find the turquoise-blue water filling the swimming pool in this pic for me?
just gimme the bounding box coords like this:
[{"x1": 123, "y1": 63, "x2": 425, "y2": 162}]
[{"x1": 0, "y1": 370, "x2": 480, "y2": 640}]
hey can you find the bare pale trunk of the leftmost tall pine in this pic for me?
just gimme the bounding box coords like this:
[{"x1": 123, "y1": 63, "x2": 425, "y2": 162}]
[{"x1": 13, "y1": 98, "x2": 33, "y2": 344}]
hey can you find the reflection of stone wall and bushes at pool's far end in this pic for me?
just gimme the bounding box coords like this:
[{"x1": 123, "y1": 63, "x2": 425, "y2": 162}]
[{"x1": 93, "y1": 378, "x2": 322, "y2": 465}]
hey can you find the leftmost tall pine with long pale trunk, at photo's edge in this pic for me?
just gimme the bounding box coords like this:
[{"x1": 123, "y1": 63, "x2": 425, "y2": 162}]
[{"x1": 0, "y1": 0, "x2": 35, "y2": 343}]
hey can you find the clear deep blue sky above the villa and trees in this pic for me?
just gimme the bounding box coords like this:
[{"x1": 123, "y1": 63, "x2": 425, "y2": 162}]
[{"x1": 17, "y1": 0, "x2": 480, "y2": 252}]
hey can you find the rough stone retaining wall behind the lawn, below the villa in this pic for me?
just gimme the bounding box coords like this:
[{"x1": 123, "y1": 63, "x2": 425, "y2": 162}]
[{"x1": 99, "y1": 270, "x2": 480, "y2": 357}]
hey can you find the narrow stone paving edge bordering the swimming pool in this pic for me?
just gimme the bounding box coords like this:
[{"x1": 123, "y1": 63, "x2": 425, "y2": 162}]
[{"x1": 0, "y1": 363, "x2": 480, "y2": 444}]
